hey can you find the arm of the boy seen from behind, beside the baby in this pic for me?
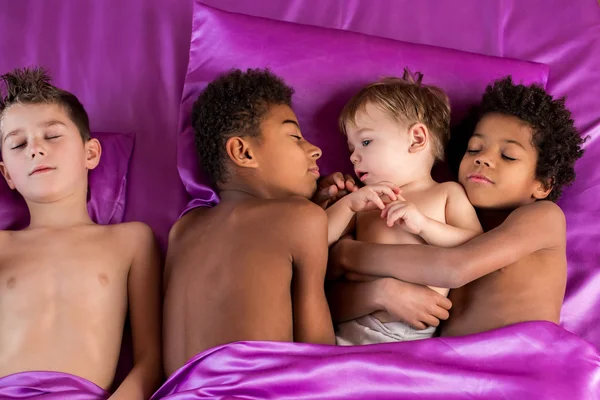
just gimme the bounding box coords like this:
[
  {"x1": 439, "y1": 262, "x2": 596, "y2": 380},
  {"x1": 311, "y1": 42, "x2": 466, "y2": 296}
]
[{"x1": 285, "y1": 201, "x2": 335, "y2": 344}]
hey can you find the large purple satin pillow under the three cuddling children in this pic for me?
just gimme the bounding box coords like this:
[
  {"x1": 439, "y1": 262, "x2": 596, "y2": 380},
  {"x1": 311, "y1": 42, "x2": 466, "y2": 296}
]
[{"x1": 177, "y1": 0, "x2": 548, "y2": 210}]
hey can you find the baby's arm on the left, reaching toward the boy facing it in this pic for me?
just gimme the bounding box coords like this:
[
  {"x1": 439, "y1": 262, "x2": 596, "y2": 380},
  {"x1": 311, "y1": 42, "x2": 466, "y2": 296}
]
[{"x1": 326, "y1": 182, "x2": 400, "y2": 245}]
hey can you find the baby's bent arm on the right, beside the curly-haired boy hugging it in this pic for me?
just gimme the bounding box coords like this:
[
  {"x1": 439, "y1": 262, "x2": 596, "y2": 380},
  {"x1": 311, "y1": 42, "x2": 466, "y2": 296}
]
[{"x1": 381, "y1": 182, "x2": 483, "y2": 247}]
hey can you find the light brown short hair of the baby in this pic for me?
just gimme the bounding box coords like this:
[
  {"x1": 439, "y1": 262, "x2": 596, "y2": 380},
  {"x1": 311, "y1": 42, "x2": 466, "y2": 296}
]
[{"x1": 339, "y1": 68, "x2": 450, "y2": 161}]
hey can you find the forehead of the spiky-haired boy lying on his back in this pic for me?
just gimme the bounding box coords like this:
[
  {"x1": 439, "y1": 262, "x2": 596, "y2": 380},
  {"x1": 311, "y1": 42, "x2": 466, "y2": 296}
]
[{"x1": 0, "y1": 104, "x2": 74, "y2": 135}]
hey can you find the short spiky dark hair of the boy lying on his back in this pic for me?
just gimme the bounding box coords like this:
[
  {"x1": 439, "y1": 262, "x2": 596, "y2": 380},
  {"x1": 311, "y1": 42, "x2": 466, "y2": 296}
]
[{"x1": 0, "y1": 66, "x2": 91, "y2": 142}]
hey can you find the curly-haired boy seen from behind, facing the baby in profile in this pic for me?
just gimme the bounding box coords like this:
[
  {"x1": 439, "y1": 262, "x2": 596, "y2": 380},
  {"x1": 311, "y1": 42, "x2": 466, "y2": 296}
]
[{"x1": 164, "y1": 69, "x2": 335, "y2": 375}]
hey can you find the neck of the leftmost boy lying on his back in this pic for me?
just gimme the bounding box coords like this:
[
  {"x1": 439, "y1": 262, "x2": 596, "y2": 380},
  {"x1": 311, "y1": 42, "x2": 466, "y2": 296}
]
[{"x1": 27, "y1": 191, "x2": 93, "y2": 229}]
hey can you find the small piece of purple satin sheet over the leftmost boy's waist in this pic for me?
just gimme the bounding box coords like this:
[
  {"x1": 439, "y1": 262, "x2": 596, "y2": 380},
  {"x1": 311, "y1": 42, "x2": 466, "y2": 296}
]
[{"x1": 0, "y1": 371, "x2": 109, "y2": 400}]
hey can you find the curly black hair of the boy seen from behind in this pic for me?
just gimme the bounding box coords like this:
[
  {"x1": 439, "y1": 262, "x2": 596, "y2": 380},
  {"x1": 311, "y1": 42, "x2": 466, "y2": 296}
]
[{"x1": 192, "y1": 69, "x2": 294, "y2": 186}]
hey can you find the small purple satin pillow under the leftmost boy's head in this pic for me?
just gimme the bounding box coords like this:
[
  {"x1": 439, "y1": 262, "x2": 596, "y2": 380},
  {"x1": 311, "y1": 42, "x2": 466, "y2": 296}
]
[{"x1": 0, "y1": 133, "x2": 134, "y2": 230}]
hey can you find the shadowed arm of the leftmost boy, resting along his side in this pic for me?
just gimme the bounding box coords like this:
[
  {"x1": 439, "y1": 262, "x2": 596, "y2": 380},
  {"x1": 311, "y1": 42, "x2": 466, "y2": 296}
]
[{"x1": 111, "y1": 224, "x2": 163, "y2": 400}]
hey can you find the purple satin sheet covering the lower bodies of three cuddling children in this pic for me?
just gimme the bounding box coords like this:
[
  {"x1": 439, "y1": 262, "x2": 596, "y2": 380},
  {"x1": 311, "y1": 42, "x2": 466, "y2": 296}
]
[{"x1": 152, "y1": 322, "x2": 600, "y2": 400}]
